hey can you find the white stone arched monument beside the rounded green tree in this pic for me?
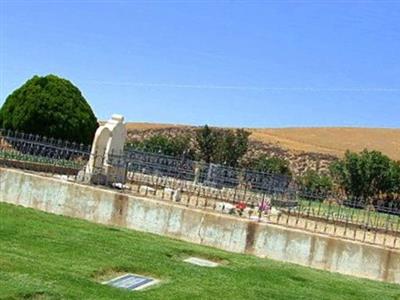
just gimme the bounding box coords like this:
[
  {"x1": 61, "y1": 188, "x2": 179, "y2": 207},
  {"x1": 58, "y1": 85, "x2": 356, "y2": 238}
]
[{"x1": 82, "y1": 115, "x2": 126, "y2": 184}]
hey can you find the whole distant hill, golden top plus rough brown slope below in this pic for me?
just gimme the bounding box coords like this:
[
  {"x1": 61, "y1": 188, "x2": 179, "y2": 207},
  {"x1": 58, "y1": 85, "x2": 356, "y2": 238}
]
[{"x1": 126, "y1": 123, "x2": 400, "y2": 174}]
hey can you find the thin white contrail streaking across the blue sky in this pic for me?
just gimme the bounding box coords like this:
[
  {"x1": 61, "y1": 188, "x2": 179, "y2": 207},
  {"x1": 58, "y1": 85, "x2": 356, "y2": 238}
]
[{"x1": 85, "y1": 81, "x2": 400, "y2": 93}]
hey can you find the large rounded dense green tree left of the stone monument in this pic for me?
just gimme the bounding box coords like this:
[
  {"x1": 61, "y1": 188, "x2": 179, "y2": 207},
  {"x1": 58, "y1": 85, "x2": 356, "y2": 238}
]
[{"x1": 0, "y1": 75, "x2": 98, "y2": 144}]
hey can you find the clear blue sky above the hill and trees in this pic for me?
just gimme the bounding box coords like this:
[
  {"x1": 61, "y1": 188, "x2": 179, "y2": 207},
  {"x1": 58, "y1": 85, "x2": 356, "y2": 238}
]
[{"x1": 0, "y1": 0, "x2": 400, "y2": 128}]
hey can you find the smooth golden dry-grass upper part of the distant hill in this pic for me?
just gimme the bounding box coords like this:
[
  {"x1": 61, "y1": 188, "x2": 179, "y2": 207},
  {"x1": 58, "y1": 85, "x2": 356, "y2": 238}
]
[{"x1": 127, "y1": 123, "x2": 400, "y2": 160}]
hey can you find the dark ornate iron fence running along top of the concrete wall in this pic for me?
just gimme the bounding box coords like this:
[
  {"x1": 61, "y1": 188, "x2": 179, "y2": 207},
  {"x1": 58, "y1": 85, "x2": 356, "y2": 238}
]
[{"x1": 0, "y1": 130, "x2": 400, "y2": 249}]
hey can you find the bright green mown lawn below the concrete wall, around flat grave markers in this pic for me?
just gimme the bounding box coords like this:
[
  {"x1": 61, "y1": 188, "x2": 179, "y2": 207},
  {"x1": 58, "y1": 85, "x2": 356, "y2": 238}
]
[{"x1": 0, "y1": 203, "x2": 400, "y2": 300}]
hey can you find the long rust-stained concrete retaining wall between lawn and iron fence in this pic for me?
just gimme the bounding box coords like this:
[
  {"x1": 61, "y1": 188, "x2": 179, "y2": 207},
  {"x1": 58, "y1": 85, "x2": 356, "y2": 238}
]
[{"x1": 0, "y1": 168, "x2": 400, "y2": 284}]
